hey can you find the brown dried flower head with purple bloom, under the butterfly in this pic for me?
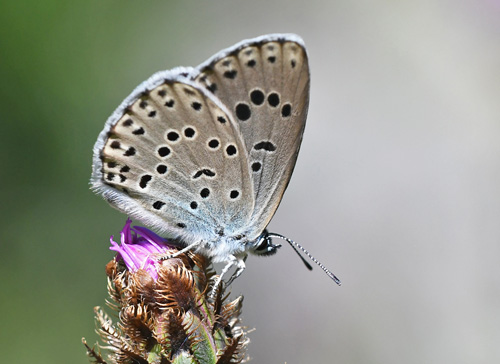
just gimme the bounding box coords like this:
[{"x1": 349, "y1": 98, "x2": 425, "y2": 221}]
[{"x1": 84, "y1": 220, "x2": 248, "y2": 364}]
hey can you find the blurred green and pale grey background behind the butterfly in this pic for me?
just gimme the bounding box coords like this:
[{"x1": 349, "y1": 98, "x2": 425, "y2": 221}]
[{"x1": 0, "y1": 0, "x2": 500, "y2": 364}]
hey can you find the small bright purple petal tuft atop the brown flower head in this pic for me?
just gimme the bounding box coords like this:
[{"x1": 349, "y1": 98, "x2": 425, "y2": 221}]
[{"x1": 109, "y1": 219, "x2": 171, "y2": 281}]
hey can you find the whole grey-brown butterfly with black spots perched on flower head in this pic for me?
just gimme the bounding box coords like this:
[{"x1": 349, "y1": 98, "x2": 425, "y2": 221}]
[{"x1": 91, "y1": 34, "x2": 340, "y2": 283}]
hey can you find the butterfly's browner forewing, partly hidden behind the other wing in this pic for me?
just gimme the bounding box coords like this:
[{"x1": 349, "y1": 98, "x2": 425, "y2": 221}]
[{"x1": 193, "y1": 35, "x2": 309, "y2": 239}]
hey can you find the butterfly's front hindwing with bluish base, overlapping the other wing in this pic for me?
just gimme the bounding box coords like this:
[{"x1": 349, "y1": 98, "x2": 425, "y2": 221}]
[{"x1": 92, "y1": 68, "x2": 254, "y2": 242}]
